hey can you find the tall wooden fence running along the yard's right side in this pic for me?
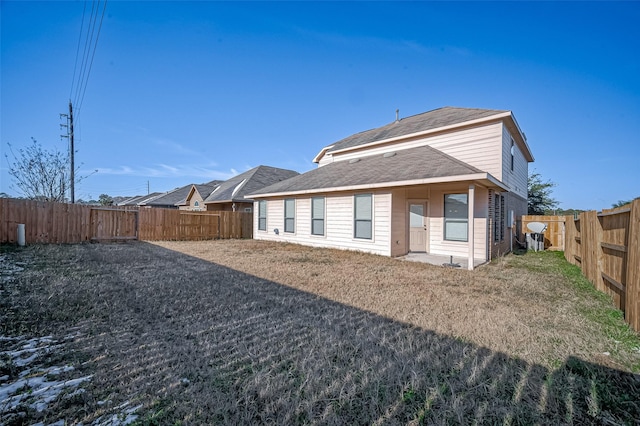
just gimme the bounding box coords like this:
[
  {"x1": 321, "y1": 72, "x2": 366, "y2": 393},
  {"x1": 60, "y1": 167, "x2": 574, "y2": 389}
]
[{"x1": 564, "y1": 199, "x2": 640, "y2": 331}]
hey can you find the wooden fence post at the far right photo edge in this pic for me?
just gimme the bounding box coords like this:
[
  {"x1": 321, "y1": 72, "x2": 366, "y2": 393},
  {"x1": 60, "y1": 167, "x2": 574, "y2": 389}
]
[{"x1": 625, "y1": 199, "x2": 640, "y2": 331}]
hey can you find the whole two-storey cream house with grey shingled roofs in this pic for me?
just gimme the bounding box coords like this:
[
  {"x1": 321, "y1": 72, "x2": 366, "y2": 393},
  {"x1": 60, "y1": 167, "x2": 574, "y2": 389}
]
[{"x1": 250, "y1": 107, "x2": 533, "y2": 268}]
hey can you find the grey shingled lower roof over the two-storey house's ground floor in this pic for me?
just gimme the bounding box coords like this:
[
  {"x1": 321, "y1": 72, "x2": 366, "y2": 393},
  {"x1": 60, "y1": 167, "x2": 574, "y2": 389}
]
[{"x1": 249, "y1": 146, "x2": 503, "y2": 198}]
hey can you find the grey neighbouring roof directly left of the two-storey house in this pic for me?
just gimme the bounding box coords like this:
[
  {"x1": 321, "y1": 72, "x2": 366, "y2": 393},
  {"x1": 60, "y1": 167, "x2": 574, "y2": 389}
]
[{"x1": 204, "y1": 166, "x2": 299, "y2": 204}]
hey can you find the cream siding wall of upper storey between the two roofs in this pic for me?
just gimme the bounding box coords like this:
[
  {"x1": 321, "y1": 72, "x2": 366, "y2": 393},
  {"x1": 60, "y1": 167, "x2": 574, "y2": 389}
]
[{"x1": 319, "y1": 122, "x2": 504, "y2": 180}]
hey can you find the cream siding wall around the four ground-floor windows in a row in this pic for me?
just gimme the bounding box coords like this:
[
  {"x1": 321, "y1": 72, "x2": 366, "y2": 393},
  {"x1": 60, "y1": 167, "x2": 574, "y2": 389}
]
[{"x1": 253, "y1": 191, "x2": 392, "y2": 256}]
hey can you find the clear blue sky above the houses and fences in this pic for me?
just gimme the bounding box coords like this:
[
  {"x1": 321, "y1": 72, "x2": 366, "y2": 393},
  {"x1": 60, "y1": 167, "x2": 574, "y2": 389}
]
[{"x1": 0, "y1": 0, "x2": 640, "y2": 209}]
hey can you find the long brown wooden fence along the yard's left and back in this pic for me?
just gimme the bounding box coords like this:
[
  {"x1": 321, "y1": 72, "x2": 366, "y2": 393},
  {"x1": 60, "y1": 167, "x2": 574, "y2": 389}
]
[{"x1": 0, "y1": 198, "x2": 253, "y2": 244}]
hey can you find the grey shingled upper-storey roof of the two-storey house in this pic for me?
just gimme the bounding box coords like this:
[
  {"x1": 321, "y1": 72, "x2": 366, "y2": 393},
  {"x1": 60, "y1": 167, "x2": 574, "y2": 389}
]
[{"x1": 313, "y1": 107, "x2": 533, "y2": 163}]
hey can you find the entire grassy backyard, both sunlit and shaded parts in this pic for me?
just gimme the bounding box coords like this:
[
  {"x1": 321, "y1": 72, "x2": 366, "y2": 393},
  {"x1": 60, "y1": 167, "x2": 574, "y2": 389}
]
[{"x1": 0, "y1": 240, "x2": 640, "y2": 425}]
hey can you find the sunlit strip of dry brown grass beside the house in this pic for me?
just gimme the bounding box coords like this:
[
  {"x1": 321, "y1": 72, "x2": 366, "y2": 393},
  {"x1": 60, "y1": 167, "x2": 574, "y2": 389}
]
[{"x1": 151, "y1": 240, "x2": 636, "y2": 367}]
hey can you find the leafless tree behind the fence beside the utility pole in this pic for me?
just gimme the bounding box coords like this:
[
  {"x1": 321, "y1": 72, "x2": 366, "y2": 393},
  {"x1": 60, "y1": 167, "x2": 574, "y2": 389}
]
[{"x1": 5, "y1": 138, "x2": 82, "y2": 202}]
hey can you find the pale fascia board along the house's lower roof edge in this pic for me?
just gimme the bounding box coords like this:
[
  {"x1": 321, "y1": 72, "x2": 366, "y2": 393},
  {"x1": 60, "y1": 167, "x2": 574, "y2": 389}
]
[{"x1": 245, "y1": 173, "x2": 509, "y2": 199}]
